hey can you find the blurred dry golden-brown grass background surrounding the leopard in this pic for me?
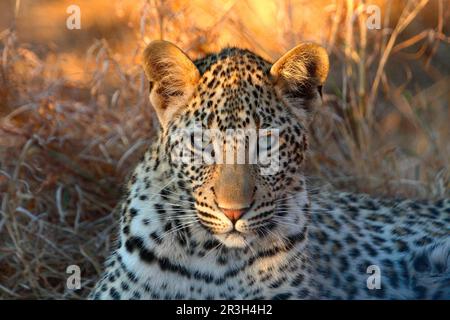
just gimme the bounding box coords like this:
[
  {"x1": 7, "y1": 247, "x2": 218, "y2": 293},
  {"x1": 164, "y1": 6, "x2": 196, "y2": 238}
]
[{"x1": 0, "y1": 0, "x2": 450, "y2": 299}]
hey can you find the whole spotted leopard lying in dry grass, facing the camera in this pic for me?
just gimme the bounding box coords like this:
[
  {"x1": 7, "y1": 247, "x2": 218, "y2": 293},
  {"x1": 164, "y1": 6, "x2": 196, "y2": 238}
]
[{"x1": 88, "y1": 40, "x2": 450, "y2": 300}]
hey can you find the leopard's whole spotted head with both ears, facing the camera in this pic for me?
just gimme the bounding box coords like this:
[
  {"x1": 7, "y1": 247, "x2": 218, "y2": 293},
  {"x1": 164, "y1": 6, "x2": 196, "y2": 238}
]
[{"x1": 144, "y1": 41, "x2": 328, "y2": 247}]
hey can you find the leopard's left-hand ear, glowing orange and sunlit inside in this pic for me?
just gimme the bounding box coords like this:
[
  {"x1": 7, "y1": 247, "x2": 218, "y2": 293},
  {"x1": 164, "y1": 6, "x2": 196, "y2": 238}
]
[{"x1": 143, "y1": 40, "x2": 200, "y2": 127}]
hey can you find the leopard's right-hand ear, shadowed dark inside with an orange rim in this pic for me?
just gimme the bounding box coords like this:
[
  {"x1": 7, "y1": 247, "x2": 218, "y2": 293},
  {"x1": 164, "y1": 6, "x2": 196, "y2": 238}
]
[{"x1": 270, "y1": 43, "x2": 329, "y2": 113}]
